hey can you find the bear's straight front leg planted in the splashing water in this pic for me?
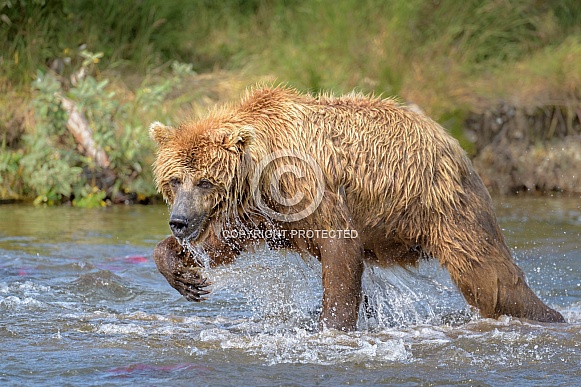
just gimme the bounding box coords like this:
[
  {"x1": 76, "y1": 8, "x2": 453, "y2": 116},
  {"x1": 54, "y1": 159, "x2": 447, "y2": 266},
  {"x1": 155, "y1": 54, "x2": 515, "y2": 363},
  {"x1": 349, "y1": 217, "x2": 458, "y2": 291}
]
[{"x1": 317, "y1": 238, "x2": 363, "y2": 331}]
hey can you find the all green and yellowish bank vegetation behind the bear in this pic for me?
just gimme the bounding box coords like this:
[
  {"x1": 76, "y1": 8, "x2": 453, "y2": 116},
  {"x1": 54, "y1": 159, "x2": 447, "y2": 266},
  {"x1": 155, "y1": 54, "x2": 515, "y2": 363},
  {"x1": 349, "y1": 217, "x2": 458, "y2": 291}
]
[{"x1": 0, "y1": 0, "x2": 581, "y2": 206}]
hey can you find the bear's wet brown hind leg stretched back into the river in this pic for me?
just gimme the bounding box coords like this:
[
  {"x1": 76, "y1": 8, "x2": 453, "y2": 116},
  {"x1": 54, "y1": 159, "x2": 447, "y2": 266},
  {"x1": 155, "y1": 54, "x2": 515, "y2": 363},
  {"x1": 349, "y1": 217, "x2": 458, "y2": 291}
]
[{"x1": 438, "y1": 174, "x2": 565, "y2": 322}]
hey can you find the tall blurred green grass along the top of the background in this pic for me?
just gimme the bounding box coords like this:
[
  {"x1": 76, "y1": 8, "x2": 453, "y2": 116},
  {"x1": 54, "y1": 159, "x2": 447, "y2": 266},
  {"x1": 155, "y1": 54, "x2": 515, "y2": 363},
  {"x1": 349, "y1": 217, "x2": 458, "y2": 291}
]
[{"x1": 0, "y1": 0, "x2": 581, "y2": 98}]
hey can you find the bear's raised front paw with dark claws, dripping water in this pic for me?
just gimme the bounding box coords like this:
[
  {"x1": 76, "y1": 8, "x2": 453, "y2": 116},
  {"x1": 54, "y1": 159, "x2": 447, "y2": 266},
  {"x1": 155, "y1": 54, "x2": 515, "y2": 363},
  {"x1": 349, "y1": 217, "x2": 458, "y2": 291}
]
[{"x1": 153, "y1": 236, "x2": 211, "y2": 302}]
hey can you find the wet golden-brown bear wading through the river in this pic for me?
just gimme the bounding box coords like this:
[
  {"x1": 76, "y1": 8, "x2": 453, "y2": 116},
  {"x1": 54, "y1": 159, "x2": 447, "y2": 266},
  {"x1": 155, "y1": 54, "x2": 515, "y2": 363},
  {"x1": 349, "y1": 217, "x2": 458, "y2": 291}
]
[{"x1": 150, "y1": 87, "x2": 564, "y2": 330}]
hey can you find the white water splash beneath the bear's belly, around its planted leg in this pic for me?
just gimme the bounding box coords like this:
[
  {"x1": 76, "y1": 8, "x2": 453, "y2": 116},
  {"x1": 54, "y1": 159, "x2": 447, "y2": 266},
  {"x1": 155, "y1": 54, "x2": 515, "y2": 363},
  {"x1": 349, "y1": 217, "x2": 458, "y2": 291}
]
[{"x1": 208, "y1": 248, "x2": 472, "y2": 330}]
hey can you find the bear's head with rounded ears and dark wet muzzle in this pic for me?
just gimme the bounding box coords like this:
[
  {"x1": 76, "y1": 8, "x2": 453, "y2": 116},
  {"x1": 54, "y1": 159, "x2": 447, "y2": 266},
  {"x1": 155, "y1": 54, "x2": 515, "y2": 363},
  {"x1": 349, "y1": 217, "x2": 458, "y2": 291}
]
[{"x1": 149, "y1": 119, "x2": 254, "y2": 242}]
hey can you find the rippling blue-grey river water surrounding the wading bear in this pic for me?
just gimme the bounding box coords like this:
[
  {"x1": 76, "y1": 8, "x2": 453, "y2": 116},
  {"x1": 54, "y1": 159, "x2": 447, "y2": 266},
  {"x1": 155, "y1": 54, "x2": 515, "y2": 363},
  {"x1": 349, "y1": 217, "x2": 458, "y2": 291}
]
[{"x1": 0, "y1": 198, "x2": 581, "y2": 386}]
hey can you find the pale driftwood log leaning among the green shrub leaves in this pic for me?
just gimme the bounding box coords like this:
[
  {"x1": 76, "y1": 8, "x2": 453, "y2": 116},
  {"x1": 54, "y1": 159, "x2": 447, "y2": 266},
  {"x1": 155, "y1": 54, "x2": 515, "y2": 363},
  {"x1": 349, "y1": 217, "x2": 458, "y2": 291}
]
[{"x1": 60, "y1": 96, "x2": 110, "y2": 168}]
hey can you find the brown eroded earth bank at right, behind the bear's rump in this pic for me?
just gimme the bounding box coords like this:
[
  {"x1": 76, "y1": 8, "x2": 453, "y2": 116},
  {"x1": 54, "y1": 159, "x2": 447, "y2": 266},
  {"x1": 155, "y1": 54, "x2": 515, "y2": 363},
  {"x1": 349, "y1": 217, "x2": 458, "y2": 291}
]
[{"x1": 465, "y1": 101, "x2": 581, "y2": 195}]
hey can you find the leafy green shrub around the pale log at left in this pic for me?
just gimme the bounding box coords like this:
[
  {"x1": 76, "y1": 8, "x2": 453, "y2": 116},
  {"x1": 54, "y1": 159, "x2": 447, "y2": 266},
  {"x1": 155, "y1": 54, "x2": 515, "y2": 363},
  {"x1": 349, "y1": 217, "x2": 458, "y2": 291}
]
[{"x1": 20, "y1": 52, "x2": 192, "y2": 207}]
